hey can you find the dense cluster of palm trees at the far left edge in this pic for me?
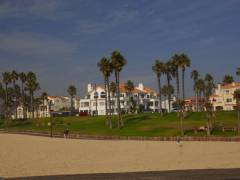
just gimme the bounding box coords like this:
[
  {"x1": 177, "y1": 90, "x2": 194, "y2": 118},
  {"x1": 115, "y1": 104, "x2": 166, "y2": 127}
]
[{"x1": 0, "y1": 70, "x2": 42, "y2": 119}]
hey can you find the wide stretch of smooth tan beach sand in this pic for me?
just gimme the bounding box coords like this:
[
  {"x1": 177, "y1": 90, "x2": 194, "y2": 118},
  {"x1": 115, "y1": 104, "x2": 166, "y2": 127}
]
[{"x1": 0, "y1": 134, "x2": 240, "y2": 177}]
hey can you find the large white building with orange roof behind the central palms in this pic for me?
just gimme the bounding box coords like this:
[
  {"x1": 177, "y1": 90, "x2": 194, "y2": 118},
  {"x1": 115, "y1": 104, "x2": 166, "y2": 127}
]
[{"x1": 79, "y1": 83, "x2": 175, "y2": 115}]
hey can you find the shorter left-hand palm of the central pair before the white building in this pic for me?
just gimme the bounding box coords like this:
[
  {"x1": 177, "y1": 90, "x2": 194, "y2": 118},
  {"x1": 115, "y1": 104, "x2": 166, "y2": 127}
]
[{"x1": 97, "y1": 57, "x2": 112, "y2": 128}]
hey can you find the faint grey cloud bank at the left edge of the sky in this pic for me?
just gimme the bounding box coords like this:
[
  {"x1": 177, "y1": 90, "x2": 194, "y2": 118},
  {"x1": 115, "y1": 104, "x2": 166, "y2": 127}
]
[{"x1": 0, "y1": 33, "x2": 79, "y2": 59}]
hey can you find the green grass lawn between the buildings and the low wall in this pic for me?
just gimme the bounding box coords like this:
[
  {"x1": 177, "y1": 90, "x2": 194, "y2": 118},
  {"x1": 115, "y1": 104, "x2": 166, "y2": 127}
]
[{"x1": 0, "y1": 111, "x2": 237, "y2": 136}]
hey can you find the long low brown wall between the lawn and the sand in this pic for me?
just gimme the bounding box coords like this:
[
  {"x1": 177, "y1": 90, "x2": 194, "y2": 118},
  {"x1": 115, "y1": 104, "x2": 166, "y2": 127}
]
[{"x1": 0, "y1": 130, "x2": 240, "y2": 142}]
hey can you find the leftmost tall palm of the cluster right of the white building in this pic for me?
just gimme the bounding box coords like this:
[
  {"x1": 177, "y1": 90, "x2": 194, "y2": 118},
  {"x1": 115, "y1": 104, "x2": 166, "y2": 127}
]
[{"x1": 152, "y1": 60, "x2": 164, "y2": 115}]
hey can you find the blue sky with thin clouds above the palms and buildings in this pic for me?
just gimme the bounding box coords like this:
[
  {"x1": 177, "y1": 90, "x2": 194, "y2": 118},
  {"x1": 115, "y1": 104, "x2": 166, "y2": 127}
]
[{"x1": 0, "y1": 0, "x2": 240, "y2": 96}]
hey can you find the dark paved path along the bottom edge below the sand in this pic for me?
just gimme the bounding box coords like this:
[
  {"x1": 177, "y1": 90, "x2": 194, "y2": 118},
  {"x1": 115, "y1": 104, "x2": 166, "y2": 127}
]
[{"x1": 8, "y1": 169, "x2": 240, "y2": 180}]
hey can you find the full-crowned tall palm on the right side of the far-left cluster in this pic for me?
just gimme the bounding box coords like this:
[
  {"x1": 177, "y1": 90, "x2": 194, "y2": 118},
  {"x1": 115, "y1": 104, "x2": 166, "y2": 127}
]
[{"x1": 26, "y1": 72, "x2": 40, "y2": 118}]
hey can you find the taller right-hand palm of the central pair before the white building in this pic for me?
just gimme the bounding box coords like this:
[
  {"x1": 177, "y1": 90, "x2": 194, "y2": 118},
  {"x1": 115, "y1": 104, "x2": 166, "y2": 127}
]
[{"x1": 111, "y1": 51, "x2": 127, "y2": 128}]
